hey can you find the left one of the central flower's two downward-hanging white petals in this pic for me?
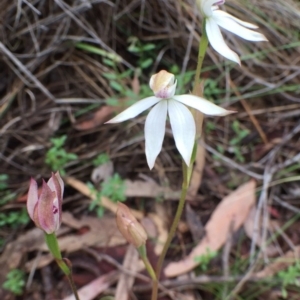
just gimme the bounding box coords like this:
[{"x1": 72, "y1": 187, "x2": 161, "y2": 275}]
[{"x1": 145, "y1": 100, "x2": 168, "y2": 170}]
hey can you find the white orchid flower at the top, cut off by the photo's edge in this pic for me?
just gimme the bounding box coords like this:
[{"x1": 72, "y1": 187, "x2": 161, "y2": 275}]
[{"x1": 197, "y1": 0, "x2": 267, "y2": 64}]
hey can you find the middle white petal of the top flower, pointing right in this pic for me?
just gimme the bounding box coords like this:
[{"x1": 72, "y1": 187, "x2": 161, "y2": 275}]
[{"x1": 213, "y1": 10, "x2": 267, "y2": 42}]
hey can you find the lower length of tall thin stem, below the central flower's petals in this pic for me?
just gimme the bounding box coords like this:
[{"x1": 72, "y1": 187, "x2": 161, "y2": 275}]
[{"x1": 151, "y1": 162, "x2": 192, "y2": 300}]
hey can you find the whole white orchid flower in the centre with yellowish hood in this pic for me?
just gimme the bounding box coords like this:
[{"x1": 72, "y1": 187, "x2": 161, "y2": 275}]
[{"x1": 107, "y1": 70, "x2": 232, "y2": 169}]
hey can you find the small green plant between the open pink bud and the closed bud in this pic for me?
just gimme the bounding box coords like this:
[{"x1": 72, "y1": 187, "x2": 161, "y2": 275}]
[{"x1": 87, "y1": 174, "x2": 126, "y2": 218}]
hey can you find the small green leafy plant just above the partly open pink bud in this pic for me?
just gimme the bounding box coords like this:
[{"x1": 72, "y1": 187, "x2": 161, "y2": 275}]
[{"x1": 45, "y1": 135, "x2": 78, "y2": 176}]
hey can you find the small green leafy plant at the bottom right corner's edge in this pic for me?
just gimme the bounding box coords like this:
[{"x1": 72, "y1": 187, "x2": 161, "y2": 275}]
[{"x1": 277, "y1": 261, "x2": 300, "y2": 299}]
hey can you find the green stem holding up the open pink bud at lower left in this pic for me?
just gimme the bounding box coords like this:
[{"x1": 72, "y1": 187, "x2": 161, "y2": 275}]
[{"x1": 45, "y1": 233, "x2": 80, "y2": 300}]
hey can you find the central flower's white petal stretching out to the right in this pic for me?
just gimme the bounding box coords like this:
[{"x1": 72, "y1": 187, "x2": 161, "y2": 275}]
[{"x1": 172, "y1": 95, "x2": 234, "y2": 116}]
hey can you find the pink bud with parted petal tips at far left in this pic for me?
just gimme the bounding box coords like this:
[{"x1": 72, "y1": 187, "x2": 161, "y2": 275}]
[{"x1": 27, "y1": 172, "x2": 64, "y2": 234}]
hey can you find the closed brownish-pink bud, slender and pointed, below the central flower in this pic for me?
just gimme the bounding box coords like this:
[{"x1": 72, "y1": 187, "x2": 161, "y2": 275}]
[{"x1": 116, "y1": 202, "x2": 147, "y2": 248}]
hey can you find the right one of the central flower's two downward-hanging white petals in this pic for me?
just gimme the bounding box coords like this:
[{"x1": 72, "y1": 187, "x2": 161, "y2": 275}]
[{"x1": 168, "y1": 100, "x2": 196, "y2": 166}]
